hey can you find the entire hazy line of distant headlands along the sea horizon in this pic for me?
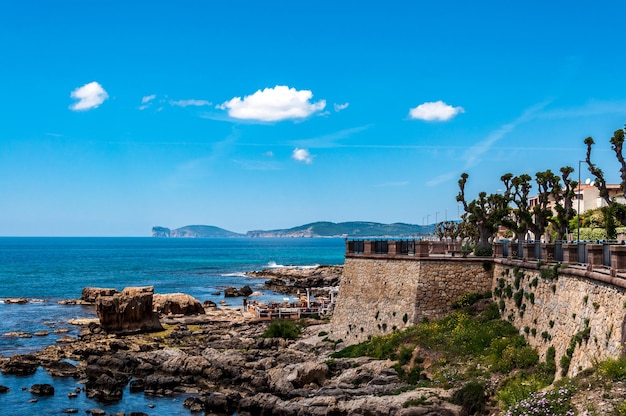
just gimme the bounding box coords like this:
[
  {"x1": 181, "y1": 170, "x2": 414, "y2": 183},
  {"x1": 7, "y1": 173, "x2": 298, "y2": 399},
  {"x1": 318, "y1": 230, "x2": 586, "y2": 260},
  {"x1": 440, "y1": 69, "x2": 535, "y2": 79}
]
[{"x1": 152, "y1": 221, "x2": 434, "y2": 238}]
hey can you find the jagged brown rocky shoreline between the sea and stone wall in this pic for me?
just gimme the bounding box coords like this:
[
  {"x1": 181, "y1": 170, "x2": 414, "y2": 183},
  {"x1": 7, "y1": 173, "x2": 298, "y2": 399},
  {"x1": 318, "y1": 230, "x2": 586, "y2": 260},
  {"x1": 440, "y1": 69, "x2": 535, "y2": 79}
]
[{"x1": 0, "y1": 266, "x2": 459, "y2": 416}]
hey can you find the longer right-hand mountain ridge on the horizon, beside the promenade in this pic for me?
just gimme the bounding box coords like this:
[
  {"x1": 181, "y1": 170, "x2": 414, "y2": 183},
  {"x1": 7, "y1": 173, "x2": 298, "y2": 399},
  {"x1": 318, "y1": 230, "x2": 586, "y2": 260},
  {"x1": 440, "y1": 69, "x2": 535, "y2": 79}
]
[{"x1": 246, "y1": 221, "x2": 426, "y2": 238}]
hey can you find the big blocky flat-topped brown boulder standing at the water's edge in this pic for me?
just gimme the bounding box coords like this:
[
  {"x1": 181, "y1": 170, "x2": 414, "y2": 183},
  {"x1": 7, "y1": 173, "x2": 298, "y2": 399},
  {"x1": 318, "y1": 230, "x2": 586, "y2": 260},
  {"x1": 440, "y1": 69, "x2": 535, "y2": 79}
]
[{"x1": 96, "y1": 286, "x2": 163, "y2": 334}]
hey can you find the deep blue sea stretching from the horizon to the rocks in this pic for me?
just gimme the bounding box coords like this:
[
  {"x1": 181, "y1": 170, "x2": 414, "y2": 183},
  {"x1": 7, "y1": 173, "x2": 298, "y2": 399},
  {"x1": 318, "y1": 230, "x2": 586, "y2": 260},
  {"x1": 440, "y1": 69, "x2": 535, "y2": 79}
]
[{"x1": 0, "y1": 237, "x2": 345, "y2": 415}]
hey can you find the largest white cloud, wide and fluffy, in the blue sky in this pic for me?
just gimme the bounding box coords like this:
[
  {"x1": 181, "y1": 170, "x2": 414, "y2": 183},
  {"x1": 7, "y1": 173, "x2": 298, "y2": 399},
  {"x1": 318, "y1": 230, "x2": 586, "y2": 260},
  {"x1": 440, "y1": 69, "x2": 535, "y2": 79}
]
[{"x1": 217, "y1": 85, "x2": 326, "y2": 121}]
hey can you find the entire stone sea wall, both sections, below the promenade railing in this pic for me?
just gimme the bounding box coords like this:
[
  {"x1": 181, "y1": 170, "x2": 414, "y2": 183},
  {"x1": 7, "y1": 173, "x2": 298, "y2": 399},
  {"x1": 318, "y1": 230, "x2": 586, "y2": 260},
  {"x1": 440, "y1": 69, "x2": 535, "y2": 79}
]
[{"x1": 330, "y1": 255, "x2": 626, "y2": 376}]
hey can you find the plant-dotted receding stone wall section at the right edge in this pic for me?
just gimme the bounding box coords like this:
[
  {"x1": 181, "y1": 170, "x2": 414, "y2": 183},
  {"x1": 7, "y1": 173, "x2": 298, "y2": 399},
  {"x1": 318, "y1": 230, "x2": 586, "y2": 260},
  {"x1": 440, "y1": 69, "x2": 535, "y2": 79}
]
[{"x1": 493, "y1": 261, "x2": 626, "y2": 376}]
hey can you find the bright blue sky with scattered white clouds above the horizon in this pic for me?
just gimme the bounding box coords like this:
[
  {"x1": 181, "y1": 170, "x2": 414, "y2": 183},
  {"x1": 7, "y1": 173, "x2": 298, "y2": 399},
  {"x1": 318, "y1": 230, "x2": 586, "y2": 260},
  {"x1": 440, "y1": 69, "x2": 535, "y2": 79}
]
[{"x1": 0, "y1": 0, "x2": 626, "y2": 236}]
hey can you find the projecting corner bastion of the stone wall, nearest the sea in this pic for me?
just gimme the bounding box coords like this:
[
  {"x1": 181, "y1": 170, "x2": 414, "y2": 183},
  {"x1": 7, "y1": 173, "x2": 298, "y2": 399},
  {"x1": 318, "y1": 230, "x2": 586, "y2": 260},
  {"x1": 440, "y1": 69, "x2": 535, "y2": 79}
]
[{"x1": 330, "y1": 256, "x2": 493, "y2": 345}]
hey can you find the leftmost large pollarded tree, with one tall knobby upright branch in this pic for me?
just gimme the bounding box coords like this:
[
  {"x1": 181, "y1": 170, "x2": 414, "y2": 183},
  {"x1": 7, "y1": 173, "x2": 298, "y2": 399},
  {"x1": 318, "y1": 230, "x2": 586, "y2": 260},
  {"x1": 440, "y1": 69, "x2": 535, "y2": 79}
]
[{"x1": 456, "y1": 173, "x2": 509, "y2": 255}]
